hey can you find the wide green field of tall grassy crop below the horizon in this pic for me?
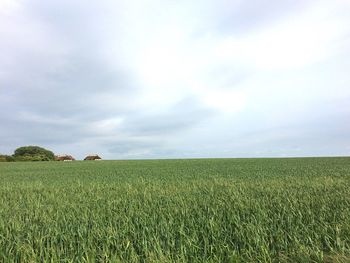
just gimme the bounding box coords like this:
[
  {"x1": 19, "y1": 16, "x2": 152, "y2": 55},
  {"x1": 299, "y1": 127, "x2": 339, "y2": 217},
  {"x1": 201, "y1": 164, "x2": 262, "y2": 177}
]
[{"x1": 0, "y1": 158, "x2": 350, "y2": 262}]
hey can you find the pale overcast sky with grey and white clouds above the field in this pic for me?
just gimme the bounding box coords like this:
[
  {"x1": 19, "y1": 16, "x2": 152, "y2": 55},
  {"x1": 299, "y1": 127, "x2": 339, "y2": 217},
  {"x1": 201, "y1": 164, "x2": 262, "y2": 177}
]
[{"x1": 0, "y1": 0, "x2": 350, "y2": 159}]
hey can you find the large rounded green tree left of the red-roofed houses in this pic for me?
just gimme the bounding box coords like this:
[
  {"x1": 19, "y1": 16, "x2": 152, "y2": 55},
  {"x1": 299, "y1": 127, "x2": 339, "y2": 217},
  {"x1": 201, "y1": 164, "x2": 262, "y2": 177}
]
[{"x1": 13, "y1": 146, "x2": 55, "y2": 161}]
